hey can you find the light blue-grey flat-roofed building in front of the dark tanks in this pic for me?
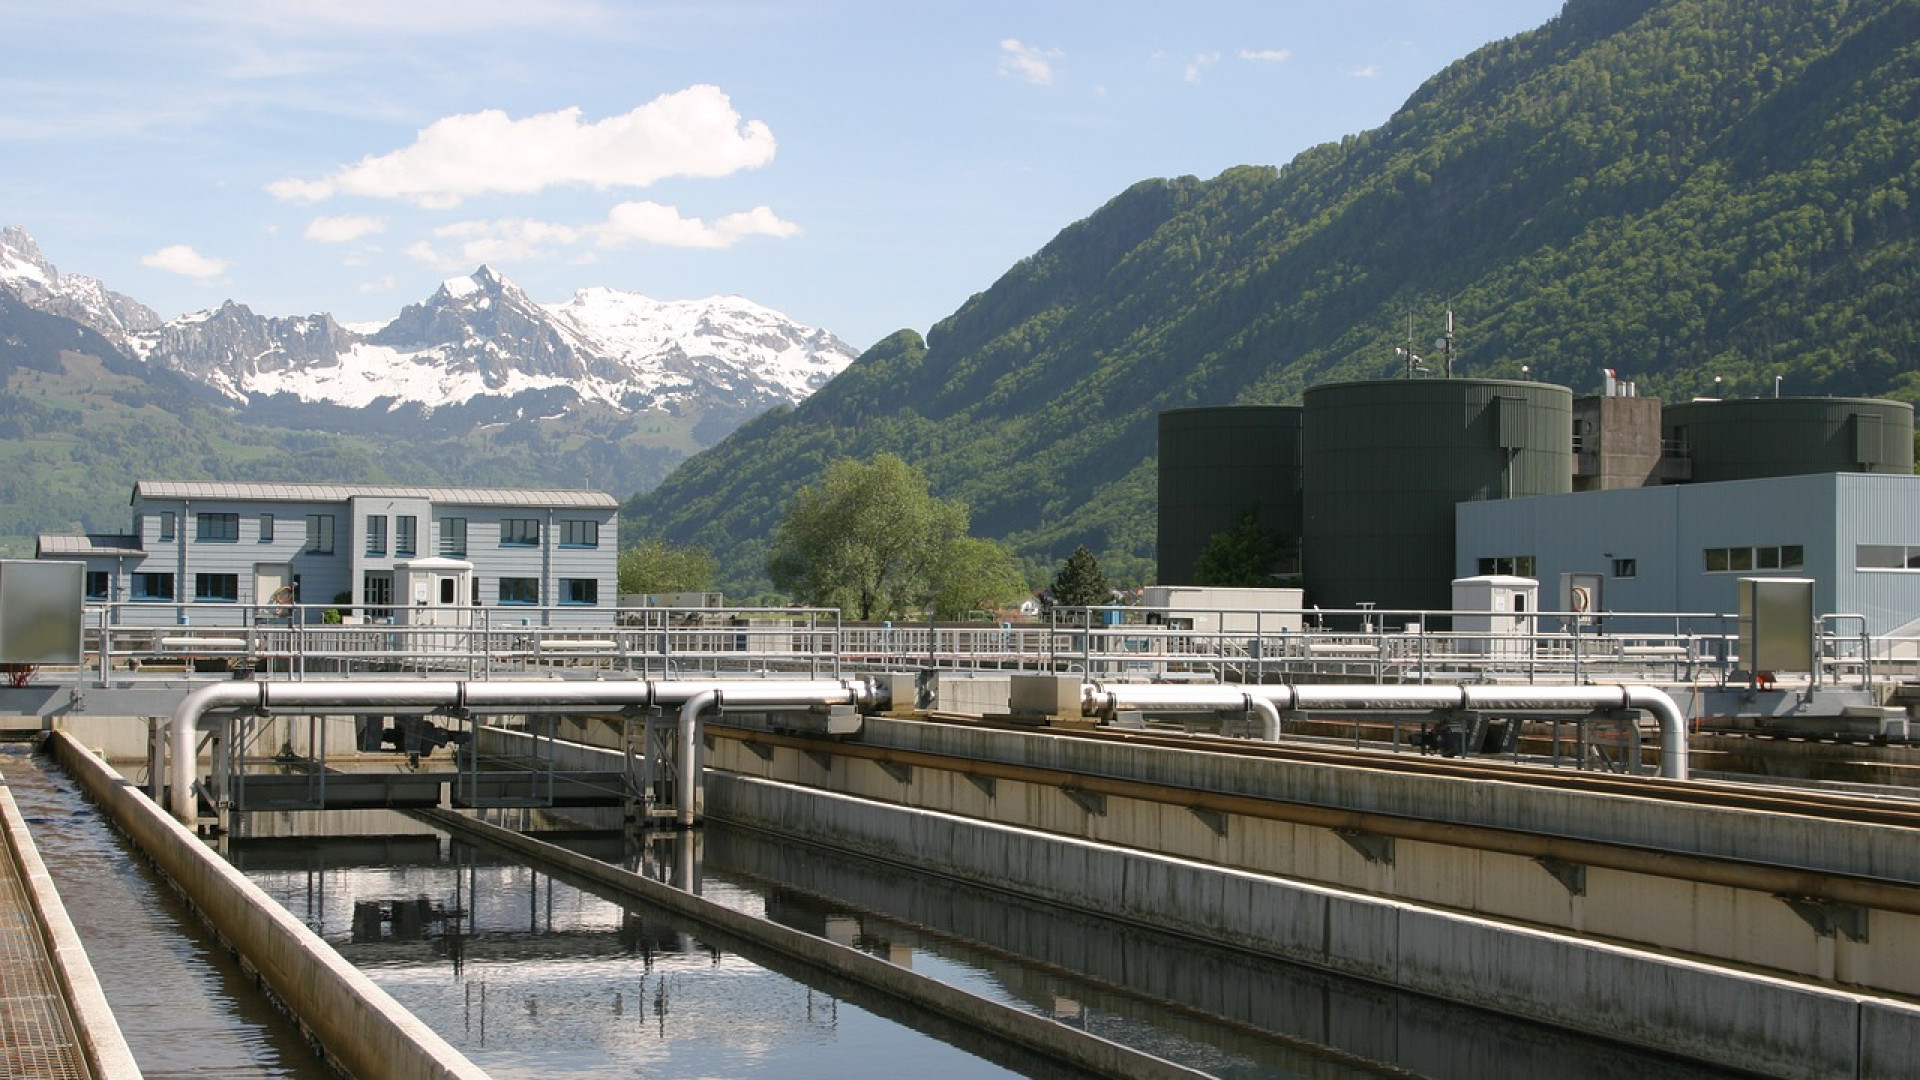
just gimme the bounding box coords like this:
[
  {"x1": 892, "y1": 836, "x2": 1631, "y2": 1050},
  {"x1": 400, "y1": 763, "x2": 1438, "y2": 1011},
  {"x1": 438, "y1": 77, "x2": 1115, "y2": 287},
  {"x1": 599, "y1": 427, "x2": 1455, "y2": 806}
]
[{"x1": 1453, "y1": 473, "x2": 1920, "y2": 634}]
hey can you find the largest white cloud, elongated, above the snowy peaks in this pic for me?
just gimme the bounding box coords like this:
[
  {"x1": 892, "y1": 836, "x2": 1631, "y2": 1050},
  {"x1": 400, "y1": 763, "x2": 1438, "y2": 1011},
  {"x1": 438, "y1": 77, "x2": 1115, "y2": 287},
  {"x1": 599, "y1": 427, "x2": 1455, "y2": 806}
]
[{"x1": 267, "y1": 86, "x2": 774, "y2": 209}]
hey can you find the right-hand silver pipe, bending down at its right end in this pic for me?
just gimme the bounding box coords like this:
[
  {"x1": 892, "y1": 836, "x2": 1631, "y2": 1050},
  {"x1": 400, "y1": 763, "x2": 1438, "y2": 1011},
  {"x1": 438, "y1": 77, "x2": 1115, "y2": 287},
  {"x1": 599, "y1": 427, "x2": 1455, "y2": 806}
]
[{"x1": 1081, "y1": 682, "x2": 1688, "y2": 780}]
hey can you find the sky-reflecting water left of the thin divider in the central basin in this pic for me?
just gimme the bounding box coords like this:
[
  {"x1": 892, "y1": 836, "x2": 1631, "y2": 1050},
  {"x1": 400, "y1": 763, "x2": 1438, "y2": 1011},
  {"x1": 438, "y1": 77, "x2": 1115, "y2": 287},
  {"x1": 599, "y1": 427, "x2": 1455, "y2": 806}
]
[{"x1": 228, "y1": 815, "x2": 1033, "y2": 1080}]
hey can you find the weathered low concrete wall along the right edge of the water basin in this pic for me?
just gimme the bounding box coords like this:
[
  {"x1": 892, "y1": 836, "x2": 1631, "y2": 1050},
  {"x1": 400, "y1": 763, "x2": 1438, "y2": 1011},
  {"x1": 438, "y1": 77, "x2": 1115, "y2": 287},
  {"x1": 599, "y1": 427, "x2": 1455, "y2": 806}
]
[{"x1": 707, "y1": 774, "x2": 1920, "y2": 1080}]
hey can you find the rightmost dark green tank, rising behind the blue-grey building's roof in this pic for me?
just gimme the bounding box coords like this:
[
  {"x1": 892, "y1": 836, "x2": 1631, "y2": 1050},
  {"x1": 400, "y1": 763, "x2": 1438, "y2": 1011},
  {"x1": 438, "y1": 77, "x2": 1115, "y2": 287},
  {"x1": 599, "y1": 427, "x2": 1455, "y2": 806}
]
[{"x1": 1661, "y1": 398, "x2": 1914, "y2": 484}]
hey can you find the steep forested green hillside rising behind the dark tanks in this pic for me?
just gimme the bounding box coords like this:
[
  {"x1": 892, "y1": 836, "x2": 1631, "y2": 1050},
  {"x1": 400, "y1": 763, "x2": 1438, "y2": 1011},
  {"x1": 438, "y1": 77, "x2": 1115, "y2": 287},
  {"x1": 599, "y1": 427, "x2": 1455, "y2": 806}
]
[{"x1": 626, "y1": 0, "x2": 1920, "y2": 596}]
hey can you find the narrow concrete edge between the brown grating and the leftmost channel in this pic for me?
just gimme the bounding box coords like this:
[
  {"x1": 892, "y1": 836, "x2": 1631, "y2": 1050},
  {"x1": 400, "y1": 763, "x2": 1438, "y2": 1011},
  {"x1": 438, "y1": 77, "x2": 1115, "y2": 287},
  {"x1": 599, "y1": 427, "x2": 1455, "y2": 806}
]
[{"x1": 0, "y1": 786, "x2": 140, "y2": 1080}]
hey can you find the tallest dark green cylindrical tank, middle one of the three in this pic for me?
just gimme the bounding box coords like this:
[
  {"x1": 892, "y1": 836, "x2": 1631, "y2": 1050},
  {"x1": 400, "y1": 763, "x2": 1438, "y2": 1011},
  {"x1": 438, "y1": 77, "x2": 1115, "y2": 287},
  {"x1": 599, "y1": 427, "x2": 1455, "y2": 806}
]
[{"x1": 1300, "y1": 379, "x2": 1572, "y2": 611}]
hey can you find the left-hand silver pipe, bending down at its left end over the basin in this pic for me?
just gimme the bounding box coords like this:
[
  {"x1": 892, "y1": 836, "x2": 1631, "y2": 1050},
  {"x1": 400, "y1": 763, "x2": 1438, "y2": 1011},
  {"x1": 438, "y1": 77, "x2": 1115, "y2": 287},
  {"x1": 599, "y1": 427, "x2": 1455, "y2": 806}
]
[{"x1": 167, "y1": 678, "x2": 877, "y2": 824}]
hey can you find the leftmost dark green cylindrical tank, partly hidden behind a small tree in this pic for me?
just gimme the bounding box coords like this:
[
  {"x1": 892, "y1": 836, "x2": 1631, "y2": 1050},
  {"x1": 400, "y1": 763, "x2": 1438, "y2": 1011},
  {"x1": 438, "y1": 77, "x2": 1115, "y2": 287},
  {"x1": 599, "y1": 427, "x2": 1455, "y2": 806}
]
[{"x1": 1158, "y1": 405, "x2": 1302, "y2": 584}]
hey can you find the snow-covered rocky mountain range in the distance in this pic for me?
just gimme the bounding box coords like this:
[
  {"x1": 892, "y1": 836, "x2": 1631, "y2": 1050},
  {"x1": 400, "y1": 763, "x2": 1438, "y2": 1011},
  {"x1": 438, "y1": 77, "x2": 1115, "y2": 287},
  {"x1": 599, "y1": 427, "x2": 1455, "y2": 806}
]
[{"x1": 0, "y1": 229, "x2": 854, "y2": 417}]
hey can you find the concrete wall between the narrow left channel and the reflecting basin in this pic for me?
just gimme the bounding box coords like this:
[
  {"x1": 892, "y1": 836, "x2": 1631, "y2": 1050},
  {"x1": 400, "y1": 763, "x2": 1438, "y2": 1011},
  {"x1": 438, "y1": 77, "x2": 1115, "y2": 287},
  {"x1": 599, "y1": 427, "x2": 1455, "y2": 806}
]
[{"x1": 50, "y1": 732, "x2": 486, "y2": 1080}]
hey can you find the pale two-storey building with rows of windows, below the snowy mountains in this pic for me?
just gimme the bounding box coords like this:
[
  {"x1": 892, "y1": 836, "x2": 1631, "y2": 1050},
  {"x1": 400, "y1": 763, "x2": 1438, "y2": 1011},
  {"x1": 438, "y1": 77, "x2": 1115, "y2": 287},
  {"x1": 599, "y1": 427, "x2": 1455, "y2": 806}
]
[{"x1": 36, "y1": 480, "x2": 620, "y2": 626}]
